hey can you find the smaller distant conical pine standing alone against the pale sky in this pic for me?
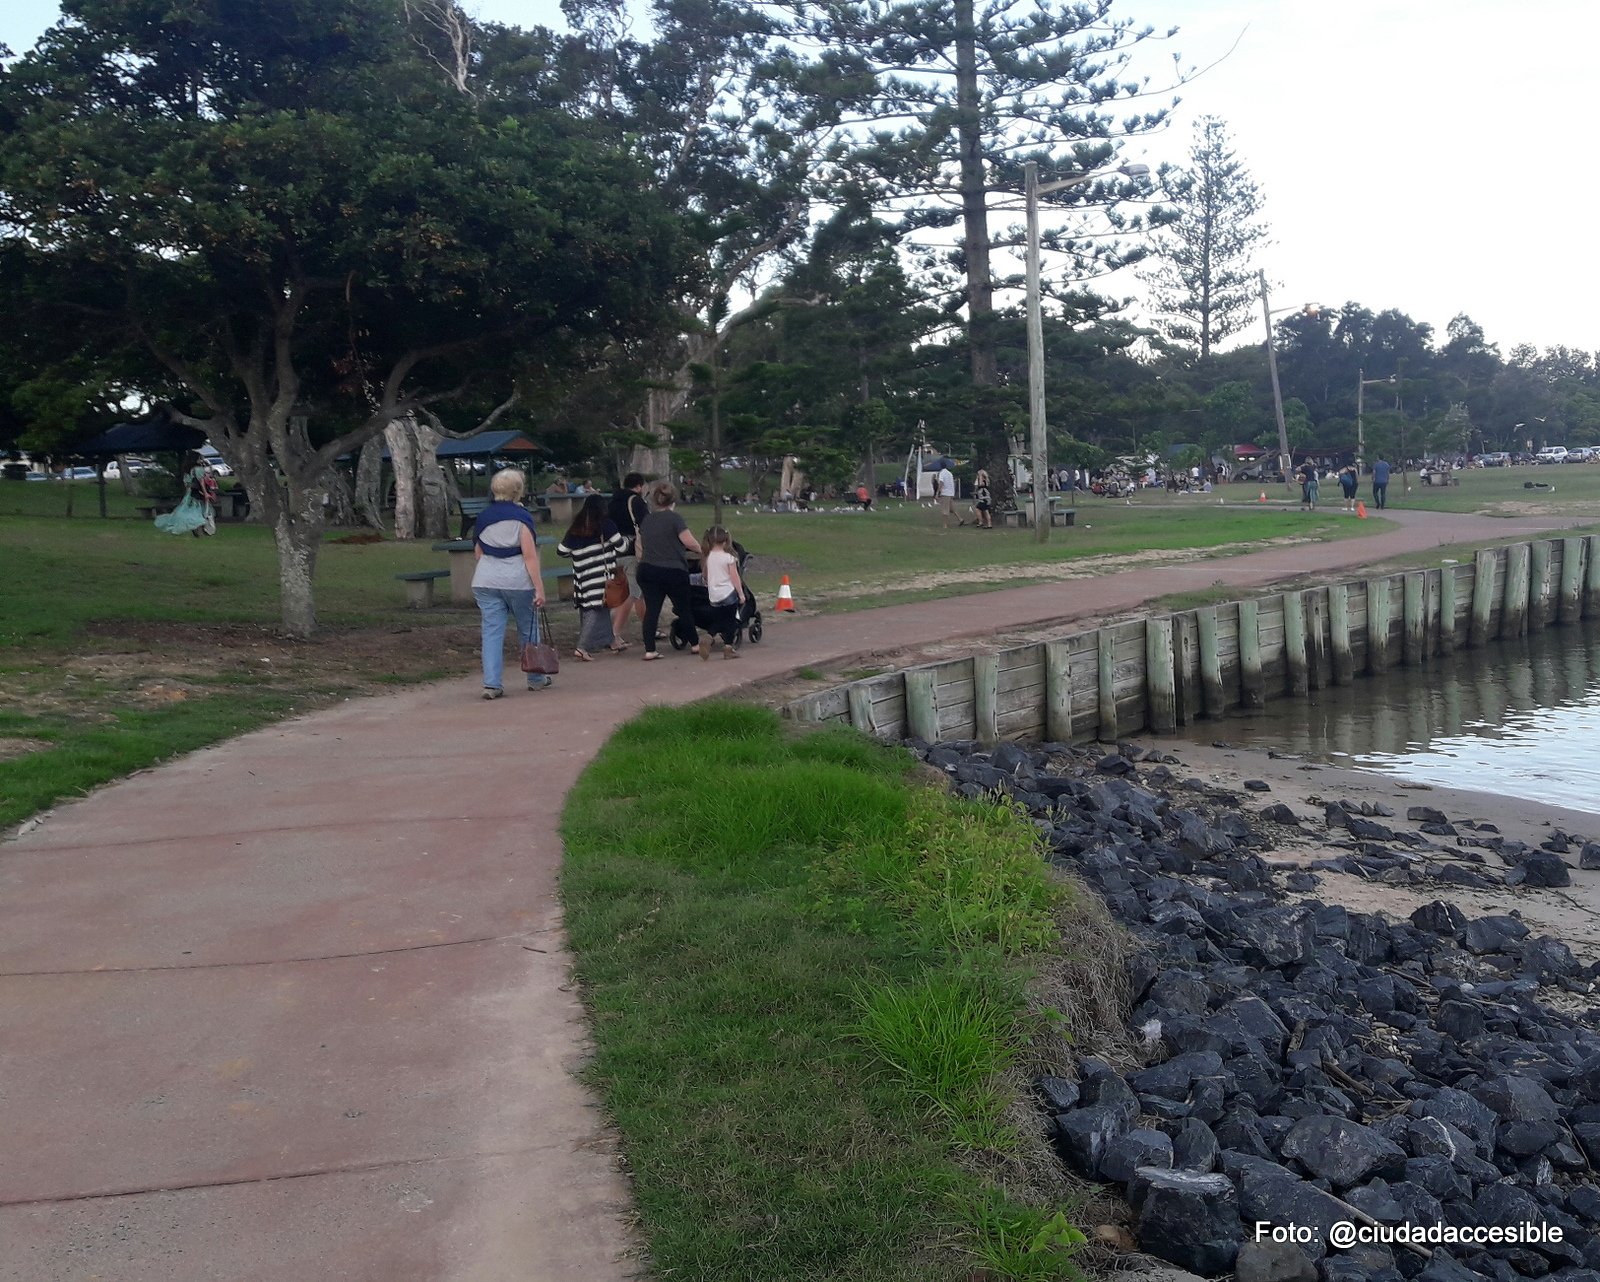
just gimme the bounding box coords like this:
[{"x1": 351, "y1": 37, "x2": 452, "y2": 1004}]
[{"x1": 1146, "y1": 115, "x2": 1267, "y2": 360}]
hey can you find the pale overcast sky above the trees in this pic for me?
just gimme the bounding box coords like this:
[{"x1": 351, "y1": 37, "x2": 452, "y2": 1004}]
[{"x1": 0, "y1": 0, "x2": 1600, "y2": 360}]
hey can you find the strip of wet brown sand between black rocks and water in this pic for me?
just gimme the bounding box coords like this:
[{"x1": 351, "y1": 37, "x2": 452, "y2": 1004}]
[{"x1": 1138, "y1": 727, "x2": 1600, "y2": 962}]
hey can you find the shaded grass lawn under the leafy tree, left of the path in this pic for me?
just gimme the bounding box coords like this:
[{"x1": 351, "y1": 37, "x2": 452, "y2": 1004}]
[{"x1": 0, "y1": 482, "x2": 480, "y2": 829}]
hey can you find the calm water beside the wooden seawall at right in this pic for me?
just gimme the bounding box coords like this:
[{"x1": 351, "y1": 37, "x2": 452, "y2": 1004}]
[{"x1": 1187, "y1": 621, "x2": 1600, "y2": 815}]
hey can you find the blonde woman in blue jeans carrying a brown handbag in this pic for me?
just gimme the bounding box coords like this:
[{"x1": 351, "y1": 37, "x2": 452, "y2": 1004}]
[{"x1": 472, "y1": 467, "x2": 550, "y2": 699}]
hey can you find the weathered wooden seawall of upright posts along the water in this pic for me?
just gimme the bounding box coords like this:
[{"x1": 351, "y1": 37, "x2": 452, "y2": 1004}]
[{"x1": 784, "y1": 535, "x2": 1600, "y2": 743}]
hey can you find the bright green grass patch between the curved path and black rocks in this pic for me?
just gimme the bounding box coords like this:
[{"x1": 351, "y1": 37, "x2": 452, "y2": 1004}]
[{"x1": 562, "y1": 703, "x2": 1075, "y2": 1282}]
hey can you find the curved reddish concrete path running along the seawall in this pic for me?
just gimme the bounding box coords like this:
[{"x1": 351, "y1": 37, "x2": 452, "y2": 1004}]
[{"x1": 0, "y1": 512, "x2": 1587, "y2": 1282}]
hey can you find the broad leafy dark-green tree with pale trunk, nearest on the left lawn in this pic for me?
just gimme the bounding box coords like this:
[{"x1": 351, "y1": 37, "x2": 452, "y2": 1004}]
[{"x1": 0, "y1": 0, "x2": 678, "y2": 635}]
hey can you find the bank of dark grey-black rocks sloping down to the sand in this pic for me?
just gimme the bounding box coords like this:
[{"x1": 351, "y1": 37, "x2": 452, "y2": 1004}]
[{"x1": 910, "y1": 743, "x2": 1600, "y2": 1282}]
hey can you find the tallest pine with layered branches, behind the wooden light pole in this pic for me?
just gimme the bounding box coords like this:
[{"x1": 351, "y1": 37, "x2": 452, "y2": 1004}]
[{"x1": 792, "y1": 0, "x2": 1165, "y2": 490}]
